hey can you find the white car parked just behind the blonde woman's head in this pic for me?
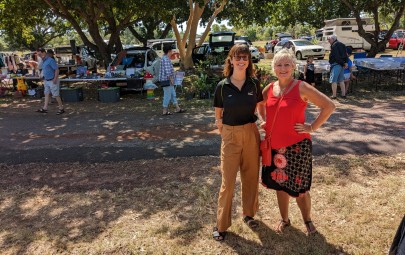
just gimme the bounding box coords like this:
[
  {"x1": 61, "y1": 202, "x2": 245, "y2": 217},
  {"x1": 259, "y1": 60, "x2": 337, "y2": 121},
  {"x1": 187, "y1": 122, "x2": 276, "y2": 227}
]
[{"x1": 274, "y1": 39, "x2": 325, "y2": 59}]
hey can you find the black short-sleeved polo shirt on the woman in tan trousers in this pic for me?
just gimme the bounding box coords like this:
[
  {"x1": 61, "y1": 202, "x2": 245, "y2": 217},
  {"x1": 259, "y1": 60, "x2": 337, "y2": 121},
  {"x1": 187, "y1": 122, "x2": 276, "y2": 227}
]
[{"x1": 214, "y1": 77, "x2": 263, "y2": 126}]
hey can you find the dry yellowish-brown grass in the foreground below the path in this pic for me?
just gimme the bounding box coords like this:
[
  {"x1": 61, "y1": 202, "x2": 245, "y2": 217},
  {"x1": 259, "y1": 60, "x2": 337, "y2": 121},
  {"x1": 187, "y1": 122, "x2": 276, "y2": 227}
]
[{"x1": 0, "y1": 154, "x2": 405, "y2": 255}]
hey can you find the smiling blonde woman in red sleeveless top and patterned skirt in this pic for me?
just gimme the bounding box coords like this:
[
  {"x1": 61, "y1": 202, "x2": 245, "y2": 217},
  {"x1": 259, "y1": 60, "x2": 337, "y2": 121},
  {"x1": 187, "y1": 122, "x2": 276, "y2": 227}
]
[{"x1": 258, "y1": 49, "x2": 335, "y2": 234}]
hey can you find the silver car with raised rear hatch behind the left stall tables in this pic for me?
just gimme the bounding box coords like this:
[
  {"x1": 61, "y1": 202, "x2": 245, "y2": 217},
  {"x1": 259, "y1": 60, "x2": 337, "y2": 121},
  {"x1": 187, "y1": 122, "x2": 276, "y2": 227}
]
[{"x1": 108, "y1": 47, "x2": 160, "y2": 90}]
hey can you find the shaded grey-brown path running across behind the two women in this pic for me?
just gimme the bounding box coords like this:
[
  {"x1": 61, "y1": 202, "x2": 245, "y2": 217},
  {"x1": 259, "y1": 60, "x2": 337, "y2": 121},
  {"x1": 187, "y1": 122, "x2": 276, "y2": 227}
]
[{"x1": 0, "y1": 93, "x2": 405, "y2": 164}]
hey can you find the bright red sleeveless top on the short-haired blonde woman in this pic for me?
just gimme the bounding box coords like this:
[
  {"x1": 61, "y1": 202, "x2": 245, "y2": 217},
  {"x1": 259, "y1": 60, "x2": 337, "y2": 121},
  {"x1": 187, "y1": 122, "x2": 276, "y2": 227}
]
[{"x1": 266, "y1": 81, "x2": 311, "y2": 149}]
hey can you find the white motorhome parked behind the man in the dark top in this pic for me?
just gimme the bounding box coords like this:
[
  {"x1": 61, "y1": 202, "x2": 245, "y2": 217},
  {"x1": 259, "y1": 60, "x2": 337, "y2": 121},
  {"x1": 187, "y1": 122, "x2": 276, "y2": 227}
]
[{"x1": 317, "y1": 18, "x2": 375, "y2": 50}]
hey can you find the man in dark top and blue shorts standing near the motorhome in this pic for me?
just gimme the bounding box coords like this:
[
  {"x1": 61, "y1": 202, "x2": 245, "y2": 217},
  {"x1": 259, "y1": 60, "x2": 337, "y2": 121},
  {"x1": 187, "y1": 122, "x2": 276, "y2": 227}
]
[{"x1": 328, "y1": 35, "x2": 348, "y2": 99}]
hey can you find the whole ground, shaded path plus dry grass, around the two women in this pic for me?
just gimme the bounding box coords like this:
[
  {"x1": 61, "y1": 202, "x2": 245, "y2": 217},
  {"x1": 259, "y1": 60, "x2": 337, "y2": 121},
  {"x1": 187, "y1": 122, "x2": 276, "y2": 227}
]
[{"x1": 0, "y1": 88, "x2": 405, "y2": 255}]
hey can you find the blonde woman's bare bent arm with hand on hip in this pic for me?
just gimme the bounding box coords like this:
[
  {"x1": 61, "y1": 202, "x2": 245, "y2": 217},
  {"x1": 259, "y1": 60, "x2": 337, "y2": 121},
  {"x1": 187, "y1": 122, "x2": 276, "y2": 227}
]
[{"x1": 295, "y1": 82, "x2": 336, "y2": 133}]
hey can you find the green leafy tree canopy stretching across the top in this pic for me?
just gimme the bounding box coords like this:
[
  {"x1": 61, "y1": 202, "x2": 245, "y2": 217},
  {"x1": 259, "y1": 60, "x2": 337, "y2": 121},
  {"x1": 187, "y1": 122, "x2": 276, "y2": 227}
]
[{"x1": 0, "y1": 0, "x2": 405, "y2": 63}]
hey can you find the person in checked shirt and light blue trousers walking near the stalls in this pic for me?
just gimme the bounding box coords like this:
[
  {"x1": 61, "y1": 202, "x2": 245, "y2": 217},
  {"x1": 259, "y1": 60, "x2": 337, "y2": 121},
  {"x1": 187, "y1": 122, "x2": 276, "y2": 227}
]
[{"x1": 159, "y1": 45, "x2": 185, "y2": 115}]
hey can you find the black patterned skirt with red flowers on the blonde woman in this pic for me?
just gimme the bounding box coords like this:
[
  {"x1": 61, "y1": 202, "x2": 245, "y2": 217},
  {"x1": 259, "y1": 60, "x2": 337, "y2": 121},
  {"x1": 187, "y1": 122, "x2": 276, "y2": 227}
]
[{"x1": 262, "y1": 139, "x2": 312, "y2": 197}]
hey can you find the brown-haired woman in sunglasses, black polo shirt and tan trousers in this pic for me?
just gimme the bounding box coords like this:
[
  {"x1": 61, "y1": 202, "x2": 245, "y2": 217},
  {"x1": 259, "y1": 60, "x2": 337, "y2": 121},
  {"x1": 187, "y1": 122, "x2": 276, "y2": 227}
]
[{"x1": 213, "y1": 44, "x2": 263, "y2": 241}]
